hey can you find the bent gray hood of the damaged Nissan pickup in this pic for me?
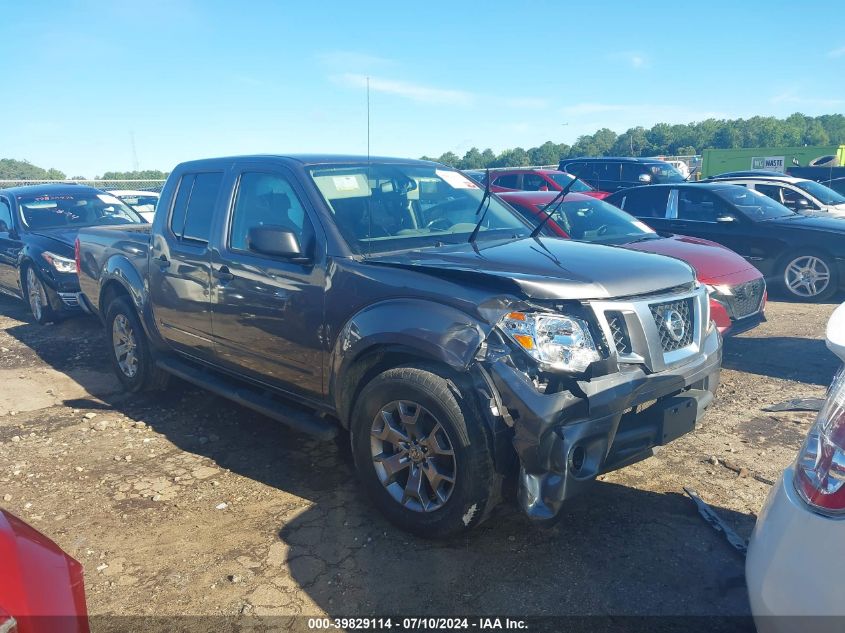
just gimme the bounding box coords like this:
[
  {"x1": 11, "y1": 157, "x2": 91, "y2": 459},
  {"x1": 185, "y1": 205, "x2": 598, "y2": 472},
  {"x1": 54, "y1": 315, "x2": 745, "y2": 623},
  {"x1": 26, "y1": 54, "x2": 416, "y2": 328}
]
[{"x1": 367, "y1": 238, "x2": 695, "y2": 300}]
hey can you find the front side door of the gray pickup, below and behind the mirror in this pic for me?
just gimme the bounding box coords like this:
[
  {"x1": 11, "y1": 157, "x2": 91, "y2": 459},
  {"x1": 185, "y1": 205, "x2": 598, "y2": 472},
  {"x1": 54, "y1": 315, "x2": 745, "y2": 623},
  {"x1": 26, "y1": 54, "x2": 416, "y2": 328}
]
[{"x1": 212, "y1": 162, "x2": 326, "y2": 398}]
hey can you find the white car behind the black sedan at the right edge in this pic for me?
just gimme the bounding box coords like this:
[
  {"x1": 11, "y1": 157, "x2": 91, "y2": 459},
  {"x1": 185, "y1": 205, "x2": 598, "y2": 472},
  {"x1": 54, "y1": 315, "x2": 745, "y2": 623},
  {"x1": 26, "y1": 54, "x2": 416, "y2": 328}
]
[{"x1": 712, "y1": 176, "x2": 845, "y2": 216}]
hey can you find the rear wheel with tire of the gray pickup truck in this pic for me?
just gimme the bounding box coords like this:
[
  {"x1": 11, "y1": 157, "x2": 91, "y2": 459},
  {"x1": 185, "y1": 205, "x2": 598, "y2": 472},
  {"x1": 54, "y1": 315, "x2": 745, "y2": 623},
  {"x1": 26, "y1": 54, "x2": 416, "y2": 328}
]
[{"x1": 106, "y1": 297, "x2": 168, "y2": 392}]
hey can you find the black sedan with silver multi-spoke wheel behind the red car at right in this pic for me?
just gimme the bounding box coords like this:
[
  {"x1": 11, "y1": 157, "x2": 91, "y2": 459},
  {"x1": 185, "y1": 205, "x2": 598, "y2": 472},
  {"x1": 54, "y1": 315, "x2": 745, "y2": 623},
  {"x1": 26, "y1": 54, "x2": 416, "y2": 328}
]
[{"x1": 606, "y1": 182, "x2": 845, "y2": 301}]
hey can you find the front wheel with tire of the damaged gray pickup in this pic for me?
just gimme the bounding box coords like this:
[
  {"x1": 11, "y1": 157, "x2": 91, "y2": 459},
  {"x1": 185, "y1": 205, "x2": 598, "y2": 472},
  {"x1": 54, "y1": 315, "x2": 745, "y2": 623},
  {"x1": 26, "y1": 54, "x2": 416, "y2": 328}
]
[{"x1": 351, "y1": 366, "x2": 501, "y2": 538}]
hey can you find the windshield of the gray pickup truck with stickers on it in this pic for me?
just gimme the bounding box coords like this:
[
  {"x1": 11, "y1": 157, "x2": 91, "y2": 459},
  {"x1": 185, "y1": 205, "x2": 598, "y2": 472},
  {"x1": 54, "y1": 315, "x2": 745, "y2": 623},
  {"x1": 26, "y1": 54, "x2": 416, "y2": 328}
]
[{"x1": 309, "y1": 163, "x2": 530, "y2": 253}]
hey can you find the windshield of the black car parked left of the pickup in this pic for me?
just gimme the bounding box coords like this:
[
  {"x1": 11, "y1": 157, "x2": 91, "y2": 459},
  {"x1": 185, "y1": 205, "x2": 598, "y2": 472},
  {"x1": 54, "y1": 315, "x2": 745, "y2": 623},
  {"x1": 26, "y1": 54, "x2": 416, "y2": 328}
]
[{"x1": 17, "y1": 191, "x2": 144, "y2": 230}]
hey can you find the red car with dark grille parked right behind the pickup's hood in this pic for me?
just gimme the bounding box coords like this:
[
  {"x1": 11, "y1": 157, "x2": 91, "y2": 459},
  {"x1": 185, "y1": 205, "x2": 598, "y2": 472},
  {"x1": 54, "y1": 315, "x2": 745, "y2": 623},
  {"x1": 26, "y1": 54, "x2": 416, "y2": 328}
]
[{"x1": 498, "y1": 191, "x2": 767, "y2": 334}]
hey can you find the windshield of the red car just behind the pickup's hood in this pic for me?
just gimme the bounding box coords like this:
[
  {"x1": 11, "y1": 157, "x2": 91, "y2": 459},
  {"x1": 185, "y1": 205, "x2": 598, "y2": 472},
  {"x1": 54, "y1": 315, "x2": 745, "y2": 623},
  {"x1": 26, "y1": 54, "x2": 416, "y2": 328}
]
[{"x1": 540, "y1": 198, "x2": 657, "y2": 244}]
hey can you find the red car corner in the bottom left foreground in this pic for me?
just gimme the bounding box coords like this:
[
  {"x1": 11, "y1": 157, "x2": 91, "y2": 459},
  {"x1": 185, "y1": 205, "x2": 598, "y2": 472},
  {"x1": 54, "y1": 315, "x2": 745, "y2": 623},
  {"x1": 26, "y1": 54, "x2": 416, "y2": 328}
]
[{"x1": 0, "y1": 510, "x2": 89, "y2": 633}]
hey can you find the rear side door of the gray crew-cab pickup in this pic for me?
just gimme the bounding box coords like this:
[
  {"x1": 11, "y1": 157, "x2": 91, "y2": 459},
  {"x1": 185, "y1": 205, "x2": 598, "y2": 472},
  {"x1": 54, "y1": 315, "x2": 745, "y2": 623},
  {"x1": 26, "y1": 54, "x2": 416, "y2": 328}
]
[{"x1": 150, "y1": 171, "x2": 223, "y2": 360}]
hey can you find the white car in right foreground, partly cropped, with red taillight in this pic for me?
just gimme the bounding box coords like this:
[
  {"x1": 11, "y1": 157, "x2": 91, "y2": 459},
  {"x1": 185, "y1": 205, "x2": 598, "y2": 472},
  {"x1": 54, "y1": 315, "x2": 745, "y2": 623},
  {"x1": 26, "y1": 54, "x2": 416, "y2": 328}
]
[{"x1": 745, "y1": 304, "x2": 845, "y2": 633}]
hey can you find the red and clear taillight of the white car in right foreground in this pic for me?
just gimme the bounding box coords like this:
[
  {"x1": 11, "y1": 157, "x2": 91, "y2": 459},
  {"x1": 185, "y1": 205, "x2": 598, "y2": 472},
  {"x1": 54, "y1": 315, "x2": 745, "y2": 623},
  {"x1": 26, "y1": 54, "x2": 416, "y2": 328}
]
[{"x1": 795, "y1": 370, "x2": 845, "y2": 516}]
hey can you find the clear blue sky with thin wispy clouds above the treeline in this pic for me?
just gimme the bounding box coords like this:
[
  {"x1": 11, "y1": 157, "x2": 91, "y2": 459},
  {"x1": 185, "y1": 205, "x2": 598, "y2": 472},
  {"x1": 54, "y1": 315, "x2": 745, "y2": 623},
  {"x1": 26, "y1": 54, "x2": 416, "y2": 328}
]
[{"x1": 0, "y1": 0, "x2": 845, "y2": 177}]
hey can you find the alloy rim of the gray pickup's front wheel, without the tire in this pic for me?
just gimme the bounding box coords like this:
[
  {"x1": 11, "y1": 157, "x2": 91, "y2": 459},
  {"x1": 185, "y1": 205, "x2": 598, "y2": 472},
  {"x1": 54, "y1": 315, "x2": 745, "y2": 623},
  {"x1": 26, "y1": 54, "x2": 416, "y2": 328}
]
[{"x1": 370, "y1": 400, "x2": 457, "y2": 512}]
